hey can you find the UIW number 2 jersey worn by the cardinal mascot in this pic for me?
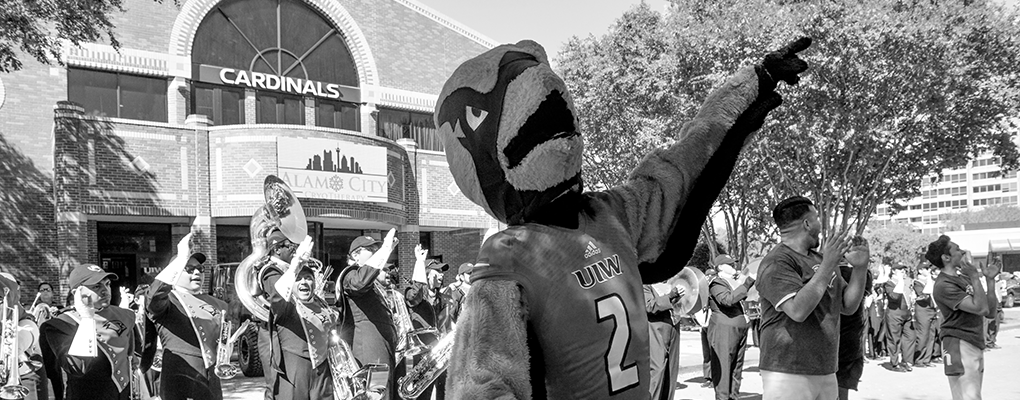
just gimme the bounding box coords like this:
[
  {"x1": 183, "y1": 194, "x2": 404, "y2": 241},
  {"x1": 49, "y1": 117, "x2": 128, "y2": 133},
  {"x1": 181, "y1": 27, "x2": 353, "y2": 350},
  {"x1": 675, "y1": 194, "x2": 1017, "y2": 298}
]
[{"x1": 471, "y1": 196, "x2": 649, "y2": 399}]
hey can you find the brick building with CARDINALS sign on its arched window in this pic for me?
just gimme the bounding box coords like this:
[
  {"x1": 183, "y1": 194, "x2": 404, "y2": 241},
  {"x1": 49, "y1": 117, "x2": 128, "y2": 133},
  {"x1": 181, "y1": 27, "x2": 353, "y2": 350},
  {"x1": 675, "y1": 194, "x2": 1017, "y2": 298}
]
[{"x1": 0, "y1": 0, "x2": 497, "y2": 302}]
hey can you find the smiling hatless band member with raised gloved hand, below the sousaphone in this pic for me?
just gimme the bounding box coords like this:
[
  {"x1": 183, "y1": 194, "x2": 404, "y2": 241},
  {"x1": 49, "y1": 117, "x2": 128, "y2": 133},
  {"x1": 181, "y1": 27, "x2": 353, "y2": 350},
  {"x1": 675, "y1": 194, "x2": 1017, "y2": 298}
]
[{"x1": 262, "y1": 235, "x2": 338, "y2": 400}]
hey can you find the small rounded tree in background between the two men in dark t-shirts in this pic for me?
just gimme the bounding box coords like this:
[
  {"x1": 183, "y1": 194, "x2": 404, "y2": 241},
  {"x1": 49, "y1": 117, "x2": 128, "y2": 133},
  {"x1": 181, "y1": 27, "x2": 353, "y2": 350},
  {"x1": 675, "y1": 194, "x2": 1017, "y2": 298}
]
[{"x1": 866, "y1": 222, "x2": 938, "y2": 268}]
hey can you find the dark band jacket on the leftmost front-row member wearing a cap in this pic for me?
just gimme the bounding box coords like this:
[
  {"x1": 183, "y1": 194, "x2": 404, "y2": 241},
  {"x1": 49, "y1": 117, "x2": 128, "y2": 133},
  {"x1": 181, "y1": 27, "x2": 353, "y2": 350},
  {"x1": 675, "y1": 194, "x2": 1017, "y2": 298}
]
[{"x1": 40, "y1": 305, "x2": 141, "y2": 400}]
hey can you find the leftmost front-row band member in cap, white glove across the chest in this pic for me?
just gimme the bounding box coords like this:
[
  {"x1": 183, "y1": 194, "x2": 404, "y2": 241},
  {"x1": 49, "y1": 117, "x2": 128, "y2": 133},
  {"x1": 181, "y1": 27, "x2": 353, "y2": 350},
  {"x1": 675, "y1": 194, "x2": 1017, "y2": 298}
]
[{"x1": 42, "y1": 264, "x2": 140, "y2": 400}]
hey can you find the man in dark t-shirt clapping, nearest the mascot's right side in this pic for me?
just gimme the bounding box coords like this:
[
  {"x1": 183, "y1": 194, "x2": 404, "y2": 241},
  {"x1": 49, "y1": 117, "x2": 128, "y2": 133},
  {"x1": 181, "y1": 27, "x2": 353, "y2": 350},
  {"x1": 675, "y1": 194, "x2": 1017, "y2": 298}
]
[{"x1": 757, "y1": 196, "x2": 870, "y2": 400}]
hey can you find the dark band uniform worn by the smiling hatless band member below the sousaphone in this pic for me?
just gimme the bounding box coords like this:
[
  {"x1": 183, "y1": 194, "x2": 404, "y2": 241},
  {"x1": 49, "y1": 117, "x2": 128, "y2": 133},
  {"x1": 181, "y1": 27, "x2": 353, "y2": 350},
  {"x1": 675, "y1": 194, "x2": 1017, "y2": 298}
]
[{"x1": 262, "y1": 269, "x2": 339, "y2": 400}]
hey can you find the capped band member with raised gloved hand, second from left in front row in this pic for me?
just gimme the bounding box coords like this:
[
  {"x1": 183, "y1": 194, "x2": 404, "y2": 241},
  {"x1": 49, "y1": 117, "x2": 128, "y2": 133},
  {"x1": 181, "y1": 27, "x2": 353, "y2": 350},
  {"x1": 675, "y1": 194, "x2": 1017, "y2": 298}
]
[{"x1": 148, "y1": 234, "x2": 226, "y2": 400}]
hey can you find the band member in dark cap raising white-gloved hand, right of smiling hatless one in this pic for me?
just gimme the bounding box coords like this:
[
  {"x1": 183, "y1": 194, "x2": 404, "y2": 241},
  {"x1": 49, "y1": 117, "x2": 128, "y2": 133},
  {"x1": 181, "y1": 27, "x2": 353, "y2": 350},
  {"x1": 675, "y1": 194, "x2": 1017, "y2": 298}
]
[{"x1": 338, "y1": 230, "x2": 397, "y2": 399}]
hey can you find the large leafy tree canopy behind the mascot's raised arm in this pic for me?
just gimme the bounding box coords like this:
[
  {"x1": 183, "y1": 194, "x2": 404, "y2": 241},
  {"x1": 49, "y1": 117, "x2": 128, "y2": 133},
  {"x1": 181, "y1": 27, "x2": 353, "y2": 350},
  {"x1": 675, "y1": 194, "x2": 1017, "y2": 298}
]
[{"x1": 558, "y1": 0, "x2": 1020, "y2": 259}]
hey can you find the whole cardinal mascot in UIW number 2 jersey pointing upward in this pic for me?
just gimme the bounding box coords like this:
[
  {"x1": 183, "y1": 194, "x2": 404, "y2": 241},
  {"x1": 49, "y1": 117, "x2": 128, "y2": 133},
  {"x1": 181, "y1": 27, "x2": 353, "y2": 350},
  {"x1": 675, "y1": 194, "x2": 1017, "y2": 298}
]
[{"x1": 436, "y1": 39, "x2": 810, "y2": 399}]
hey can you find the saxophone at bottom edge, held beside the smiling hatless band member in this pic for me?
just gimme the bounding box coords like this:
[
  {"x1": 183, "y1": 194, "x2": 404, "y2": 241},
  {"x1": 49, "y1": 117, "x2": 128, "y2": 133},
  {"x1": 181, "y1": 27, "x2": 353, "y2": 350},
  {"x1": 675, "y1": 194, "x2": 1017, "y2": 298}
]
[{"x1": 327, "y1": 330, "x2": 389, "y2": 400}]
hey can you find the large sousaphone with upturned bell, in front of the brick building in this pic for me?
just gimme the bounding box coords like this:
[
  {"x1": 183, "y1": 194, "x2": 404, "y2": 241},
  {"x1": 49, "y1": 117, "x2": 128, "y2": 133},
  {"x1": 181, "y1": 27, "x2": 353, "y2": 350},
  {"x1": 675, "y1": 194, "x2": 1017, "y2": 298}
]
[{"x1": 234, "y1": 176, "x2": 306, "y2": 321}]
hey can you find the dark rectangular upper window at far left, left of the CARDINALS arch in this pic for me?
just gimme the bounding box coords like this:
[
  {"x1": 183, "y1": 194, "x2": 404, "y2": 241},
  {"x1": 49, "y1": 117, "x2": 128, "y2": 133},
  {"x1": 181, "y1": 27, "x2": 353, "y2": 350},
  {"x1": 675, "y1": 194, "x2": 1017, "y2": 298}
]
[{"x1": 67, "y1": 68, "x2": 167, "y2": 122}]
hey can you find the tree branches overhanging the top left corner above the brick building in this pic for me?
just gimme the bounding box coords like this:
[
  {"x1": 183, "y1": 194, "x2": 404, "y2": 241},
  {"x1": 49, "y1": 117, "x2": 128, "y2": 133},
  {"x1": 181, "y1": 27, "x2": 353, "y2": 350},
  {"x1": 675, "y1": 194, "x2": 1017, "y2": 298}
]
[{"x1": 0, "y1": 0, "x2": 180, "y2": 72}]
